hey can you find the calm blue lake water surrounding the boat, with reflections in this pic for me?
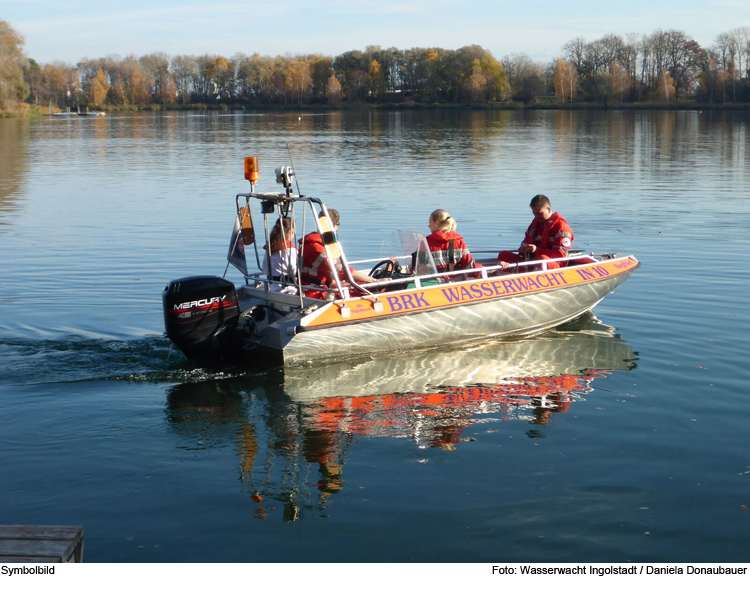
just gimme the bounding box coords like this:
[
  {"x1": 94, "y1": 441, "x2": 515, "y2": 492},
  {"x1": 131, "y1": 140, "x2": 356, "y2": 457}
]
[{"x1": 0, "y1": 111, "x2": 750, "y2": 563}]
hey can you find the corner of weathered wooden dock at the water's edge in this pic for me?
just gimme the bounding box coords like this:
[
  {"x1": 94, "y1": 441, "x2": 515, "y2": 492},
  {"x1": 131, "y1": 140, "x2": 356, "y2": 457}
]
[{"x1": 0, "y1": 525, "x2": 83, "y2": 563}]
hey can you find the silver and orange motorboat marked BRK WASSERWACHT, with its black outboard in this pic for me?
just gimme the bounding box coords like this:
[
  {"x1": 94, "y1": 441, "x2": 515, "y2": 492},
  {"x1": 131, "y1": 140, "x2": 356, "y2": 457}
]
[{"x1": 162, "y1": 157, "x2": 640, "y2": 365}]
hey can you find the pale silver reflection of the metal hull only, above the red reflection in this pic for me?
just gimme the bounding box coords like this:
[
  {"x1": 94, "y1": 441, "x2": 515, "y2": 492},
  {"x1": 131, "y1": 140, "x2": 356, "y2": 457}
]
[{"x1": 284, "y1": 314, "x2": 634, "y2": 401}]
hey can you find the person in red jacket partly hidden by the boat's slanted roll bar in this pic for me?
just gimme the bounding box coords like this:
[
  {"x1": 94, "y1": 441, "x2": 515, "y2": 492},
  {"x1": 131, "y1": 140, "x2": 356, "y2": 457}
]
[{"x1": 299, "y1": 209, "x2": 377, "y2": 300}]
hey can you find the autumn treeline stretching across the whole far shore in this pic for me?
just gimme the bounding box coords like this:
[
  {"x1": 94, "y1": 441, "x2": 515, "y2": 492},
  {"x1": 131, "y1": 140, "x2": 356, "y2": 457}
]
[{"x1": 0, "y1": 21, "x2": 750, "y2": 110}]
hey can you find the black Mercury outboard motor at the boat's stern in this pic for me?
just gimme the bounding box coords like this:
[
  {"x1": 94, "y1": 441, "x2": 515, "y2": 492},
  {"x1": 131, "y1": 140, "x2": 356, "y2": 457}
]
[{"x1": 162, "y1": 275, "x2": 240, "y2": 359}]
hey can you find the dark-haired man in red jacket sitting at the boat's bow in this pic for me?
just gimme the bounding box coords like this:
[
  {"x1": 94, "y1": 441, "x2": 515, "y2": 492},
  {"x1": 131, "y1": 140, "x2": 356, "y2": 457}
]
[{"x1": 497, "y1": 195, "x2": 574, "y2": 269}]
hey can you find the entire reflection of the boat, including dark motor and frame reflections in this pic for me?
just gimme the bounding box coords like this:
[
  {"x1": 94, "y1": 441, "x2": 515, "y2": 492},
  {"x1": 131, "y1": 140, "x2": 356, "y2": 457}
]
[{"x1": 167, "y1": 314, "x2": 636, "y2": 520}]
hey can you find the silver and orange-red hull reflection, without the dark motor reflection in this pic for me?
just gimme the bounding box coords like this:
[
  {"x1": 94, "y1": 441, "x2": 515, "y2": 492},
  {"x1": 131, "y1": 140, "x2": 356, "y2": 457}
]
[{"x1": 284, "y1": 314, "x2": 635, "y2": 446}]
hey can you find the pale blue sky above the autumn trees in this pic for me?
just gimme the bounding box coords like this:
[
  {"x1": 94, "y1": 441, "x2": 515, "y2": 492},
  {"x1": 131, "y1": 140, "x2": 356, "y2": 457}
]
[{"x1": 0, "y1": 0, "x2": 750, "y2": 65}]
